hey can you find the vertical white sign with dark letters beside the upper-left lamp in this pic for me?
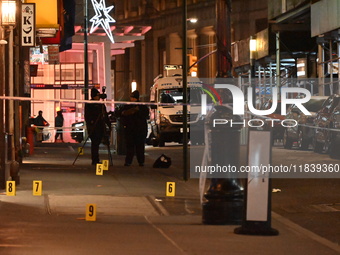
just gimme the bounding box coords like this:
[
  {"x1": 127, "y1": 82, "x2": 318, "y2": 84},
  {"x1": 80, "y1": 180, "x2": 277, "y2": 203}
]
[{"x1": 21, "y1": 3, "x2": 35, "y2": 46}]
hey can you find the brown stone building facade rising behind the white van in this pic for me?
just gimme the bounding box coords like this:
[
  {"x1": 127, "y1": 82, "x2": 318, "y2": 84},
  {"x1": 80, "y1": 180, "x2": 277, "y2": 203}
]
[{"x1": 113, "y1": 0, "x2": 267, "y2": 100}]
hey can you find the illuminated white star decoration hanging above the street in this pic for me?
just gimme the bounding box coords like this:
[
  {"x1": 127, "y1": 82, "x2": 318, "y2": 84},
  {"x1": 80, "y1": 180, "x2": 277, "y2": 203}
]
[{"x1": 90, "y1": 0, "x2": 116, "y2": 43}]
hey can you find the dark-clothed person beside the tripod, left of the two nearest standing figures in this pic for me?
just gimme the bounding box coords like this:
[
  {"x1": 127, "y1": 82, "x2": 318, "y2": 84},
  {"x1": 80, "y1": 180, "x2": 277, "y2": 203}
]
[{"x1": 85, "y1": 88, "x2": 111, "y2": 165}]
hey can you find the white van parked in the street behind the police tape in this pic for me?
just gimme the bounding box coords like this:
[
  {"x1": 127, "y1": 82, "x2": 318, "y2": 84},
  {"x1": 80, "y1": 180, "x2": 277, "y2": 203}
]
[{"x1": 150, "y1": 74, "x2": 204, "y2": 147}]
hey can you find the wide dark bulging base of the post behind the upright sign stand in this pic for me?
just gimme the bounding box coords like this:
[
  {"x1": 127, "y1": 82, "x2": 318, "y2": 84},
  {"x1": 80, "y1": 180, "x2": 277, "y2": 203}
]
[{"x1": 202, "y1": 106, "x2": 245, "y2": 225}]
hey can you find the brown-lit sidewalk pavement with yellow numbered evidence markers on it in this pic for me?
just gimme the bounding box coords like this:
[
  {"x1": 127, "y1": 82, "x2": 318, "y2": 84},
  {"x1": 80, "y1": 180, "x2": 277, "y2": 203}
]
[{"x1": 0, "y1": 144, "x2": 340, "y2": 255}]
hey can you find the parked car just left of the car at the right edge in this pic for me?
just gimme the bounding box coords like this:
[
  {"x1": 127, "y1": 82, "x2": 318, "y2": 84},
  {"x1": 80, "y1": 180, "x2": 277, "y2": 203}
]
[{"x1": 283, "y1": 96, "x2": 327, "y2": 150}]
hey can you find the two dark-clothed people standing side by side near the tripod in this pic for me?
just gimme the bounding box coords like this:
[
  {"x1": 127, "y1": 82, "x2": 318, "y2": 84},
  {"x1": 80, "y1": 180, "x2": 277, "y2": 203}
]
[{"x1": 85, "y1": 88, "x2": 149, "y2": 166}]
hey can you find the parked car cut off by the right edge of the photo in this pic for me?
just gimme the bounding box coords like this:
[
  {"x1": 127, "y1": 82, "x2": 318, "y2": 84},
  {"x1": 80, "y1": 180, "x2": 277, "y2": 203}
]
[{"x1": 313, "y1": 94, "x2": 340, "y2": 157}]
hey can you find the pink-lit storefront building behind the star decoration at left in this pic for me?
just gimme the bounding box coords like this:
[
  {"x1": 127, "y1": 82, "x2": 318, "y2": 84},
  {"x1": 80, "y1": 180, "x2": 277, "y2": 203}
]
[{"x1": 27, "y1": 0, "x2": 151, "y2": 142}]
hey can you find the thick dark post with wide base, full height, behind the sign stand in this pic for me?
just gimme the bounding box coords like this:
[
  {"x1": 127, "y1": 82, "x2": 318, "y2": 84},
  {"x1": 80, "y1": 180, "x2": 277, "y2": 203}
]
[{"x1": 202, "y1": 0, "x2": 244, "y2": 224}]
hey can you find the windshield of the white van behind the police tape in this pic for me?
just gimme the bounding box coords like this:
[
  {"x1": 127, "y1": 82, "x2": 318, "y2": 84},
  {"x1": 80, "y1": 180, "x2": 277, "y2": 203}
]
[{"x1": 159, "y1": 87, "x2": 202, "y2": 104}]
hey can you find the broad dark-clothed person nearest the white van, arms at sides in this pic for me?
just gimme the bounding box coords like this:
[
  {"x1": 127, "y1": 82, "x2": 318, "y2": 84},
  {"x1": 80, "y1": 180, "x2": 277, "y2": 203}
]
[{"x1": 116, "y1": 90, "x2": 149, "y2": 166}]
